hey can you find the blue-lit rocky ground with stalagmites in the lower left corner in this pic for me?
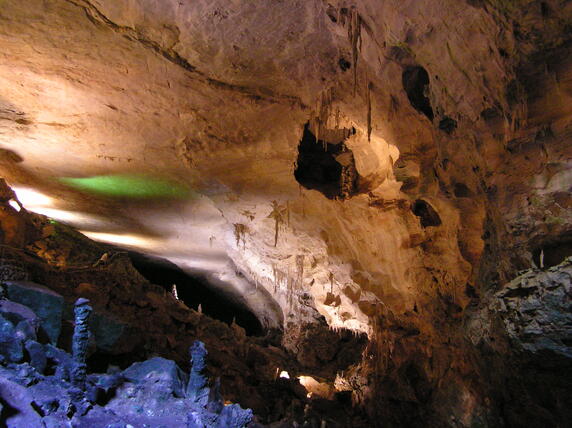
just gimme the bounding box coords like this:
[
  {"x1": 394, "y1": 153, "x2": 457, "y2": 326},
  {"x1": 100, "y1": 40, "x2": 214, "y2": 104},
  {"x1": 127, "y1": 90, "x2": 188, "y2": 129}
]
[{"x1": 0, "y1": 310, "x2": 252, "y2": 428}]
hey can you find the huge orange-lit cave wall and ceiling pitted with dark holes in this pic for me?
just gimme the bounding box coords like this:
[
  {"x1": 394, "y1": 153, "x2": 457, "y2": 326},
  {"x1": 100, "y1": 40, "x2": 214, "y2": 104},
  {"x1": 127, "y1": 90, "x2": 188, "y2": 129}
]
[{"x1": 0, "y1": 0, "x2": 572, "y2": 425}]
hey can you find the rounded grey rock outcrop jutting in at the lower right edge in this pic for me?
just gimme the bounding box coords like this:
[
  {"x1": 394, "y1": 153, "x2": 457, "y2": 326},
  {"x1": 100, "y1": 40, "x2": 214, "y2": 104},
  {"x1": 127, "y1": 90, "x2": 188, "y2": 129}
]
[{"x1": 467, "y1": 259, "x2": 572, "y2": 426}]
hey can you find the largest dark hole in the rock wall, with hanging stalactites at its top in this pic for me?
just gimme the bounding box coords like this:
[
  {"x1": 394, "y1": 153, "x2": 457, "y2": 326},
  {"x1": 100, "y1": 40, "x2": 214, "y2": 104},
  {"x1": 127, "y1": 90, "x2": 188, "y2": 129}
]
[{"x1": 294, "y1": 124, "x2": 357, "y2": 199}]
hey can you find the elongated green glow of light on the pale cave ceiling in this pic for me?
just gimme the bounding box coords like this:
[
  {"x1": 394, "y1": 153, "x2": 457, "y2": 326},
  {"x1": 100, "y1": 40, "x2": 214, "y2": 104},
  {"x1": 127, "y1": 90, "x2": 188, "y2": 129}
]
[{"x1": 59, "y1": 175, "x2": 191, "y2": 199}]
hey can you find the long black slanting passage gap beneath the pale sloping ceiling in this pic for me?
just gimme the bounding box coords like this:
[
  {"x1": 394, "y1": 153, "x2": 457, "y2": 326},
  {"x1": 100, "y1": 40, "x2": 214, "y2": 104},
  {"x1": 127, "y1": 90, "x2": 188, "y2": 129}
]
[{"x1": 129, "y1": 252, "x2": 265, "y2": 336}]
